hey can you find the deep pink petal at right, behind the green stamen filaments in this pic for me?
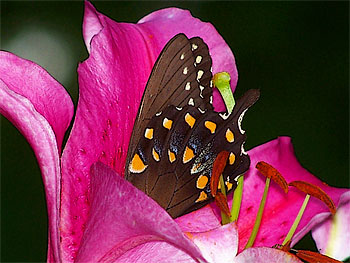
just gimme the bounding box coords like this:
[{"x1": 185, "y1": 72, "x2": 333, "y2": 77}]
[{"x1": 232, "y1": 137, "x2": 347, "y2": 251}]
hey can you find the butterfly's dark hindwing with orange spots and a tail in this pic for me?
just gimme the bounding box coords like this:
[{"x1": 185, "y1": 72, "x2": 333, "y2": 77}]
[{"x1": 128, "y1": 90, "x2": 259, "y2": 218}]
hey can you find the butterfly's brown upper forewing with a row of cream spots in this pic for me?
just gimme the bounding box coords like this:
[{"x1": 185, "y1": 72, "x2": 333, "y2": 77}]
[{"x1": 125, "y1": 34, "x2": 213, "y2": 179}]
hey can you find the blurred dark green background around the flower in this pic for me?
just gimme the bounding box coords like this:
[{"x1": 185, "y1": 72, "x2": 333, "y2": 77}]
[{"x1": 0, "y1": 1, "x2": 349, "y2": 262}]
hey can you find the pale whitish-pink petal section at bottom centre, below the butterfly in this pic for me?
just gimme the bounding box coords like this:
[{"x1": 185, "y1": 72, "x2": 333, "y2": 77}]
[{"x1": 188, "y1": 223, "x2": 238, "y2": 263}]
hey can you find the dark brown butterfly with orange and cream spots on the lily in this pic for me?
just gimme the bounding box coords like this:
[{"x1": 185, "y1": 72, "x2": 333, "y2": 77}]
[{"x1": 125, "y1": 34, "x2": 259, "y2": 218}]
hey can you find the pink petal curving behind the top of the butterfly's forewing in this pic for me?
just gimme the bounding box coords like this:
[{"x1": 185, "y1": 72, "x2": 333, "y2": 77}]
[{"x1": 138, "y1": 8, "x2": 238, "y2": 111}]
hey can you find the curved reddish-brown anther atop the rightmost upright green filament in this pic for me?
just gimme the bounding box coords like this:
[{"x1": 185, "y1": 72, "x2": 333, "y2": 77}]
[{"x1": 289, "y1": 181, "x2": 336, "y2": 215}]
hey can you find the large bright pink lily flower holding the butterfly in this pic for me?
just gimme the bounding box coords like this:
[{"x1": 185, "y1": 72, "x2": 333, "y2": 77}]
[{"x1": 0, "y1": 2, "x2": 349, "y2": 262}]
